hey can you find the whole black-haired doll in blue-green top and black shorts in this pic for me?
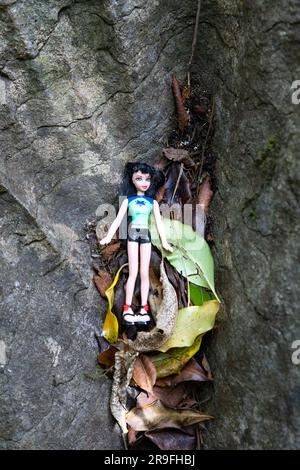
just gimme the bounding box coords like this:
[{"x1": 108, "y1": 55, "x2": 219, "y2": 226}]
[{"x1": 100, "y1": 162, "x2": 173, "y2": 326}]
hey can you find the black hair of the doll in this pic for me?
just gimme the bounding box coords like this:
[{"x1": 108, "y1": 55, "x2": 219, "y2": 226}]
[{"x1": 121, "y1": 162, "x2": 166, "y2": 199}]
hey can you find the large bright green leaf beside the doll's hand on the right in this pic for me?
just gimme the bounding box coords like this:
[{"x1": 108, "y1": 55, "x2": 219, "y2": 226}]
[{"x1": 150, "y1": 216, "x2": 220, "y2": 302}]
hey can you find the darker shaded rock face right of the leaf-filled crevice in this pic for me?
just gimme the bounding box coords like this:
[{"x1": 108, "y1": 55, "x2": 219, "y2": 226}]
[{"x1": 192, "y1": 0, "x2": 300, "y2": 449}]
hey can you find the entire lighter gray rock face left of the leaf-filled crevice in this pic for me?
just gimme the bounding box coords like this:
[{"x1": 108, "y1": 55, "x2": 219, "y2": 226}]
[{"x1": 0, "y1": 0, "x2": 197, "y2": 449}]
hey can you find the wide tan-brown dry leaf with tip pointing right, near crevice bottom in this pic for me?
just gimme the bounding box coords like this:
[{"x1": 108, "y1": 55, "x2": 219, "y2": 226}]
[{"x1": 126, "y1": 400, "x2": 214, "y2": 431}]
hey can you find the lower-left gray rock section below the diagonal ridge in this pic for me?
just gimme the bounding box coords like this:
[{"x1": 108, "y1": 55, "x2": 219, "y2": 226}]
[{"x1": 0, "y1": 187, "x2": 119, "y2": 449}]
